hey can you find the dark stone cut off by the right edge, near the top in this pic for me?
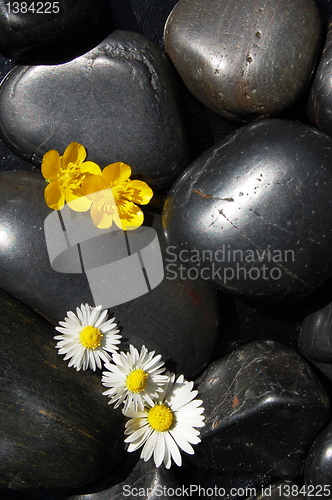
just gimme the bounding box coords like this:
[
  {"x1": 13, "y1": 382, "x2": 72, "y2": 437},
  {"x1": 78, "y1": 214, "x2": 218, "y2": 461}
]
[{"x1": 307, "y1": 19, "x2": 332, "y2": 136}]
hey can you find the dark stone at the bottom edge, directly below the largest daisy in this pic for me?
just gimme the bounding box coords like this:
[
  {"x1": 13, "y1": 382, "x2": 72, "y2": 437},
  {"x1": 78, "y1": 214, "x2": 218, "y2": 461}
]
[{"x1": 68, "y1": 454, "x2": 185, "y2": 500}]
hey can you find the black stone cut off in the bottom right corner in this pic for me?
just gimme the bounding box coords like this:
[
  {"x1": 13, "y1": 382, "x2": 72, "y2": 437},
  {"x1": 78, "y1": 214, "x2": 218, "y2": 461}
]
[{"x1": 305, "y1": 423, "x2": 332, "y2": 488}]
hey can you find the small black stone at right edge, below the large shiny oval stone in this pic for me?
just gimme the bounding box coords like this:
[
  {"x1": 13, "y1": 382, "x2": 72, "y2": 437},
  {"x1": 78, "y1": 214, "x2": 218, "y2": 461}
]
[{"x1": 299, "y1": 303, "x2": 332, "y2": 363}]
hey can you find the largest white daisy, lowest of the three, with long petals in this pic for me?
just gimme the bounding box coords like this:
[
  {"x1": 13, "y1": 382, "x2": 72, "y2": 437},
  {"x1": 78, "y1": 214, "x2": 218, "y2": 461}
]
[{"x1": 123, "y1": 374, "x2": 204, "y2": 469}]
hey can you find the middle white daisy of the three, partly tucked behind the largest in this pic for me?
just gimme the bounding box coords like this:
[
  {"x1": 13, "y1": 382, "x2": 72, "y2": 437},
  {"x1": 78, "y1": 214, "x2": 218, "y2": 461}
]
[{"x1": 101, "y1": 345, "x2": 168, "y2": 411}]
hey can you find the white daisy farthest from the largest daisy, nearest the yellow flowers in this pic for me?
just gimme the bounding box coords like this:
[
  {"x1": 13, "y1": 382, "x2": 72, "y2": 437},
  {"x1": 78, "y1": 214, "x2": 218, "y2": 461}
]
[{"x1": 54, "y1": 304, "x2": 121, "y2": 370}]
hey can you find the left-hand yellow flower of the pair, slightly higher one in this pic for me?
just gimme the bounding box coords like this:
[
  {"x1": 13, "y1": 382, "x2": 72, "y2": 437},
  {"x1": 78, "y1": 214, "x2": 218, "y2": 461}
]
[{"x1": 41, "y1": 142, "x2": 101, "y2": 211}]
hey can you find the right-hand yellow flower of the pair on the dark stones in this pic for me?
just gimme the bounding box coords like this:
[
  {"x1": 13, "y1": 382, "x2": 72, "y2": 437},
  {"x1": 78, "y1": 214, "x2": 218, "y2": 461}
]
[{"x1": 76, "y1": 162, "x2": 153, "y2": 230}]
